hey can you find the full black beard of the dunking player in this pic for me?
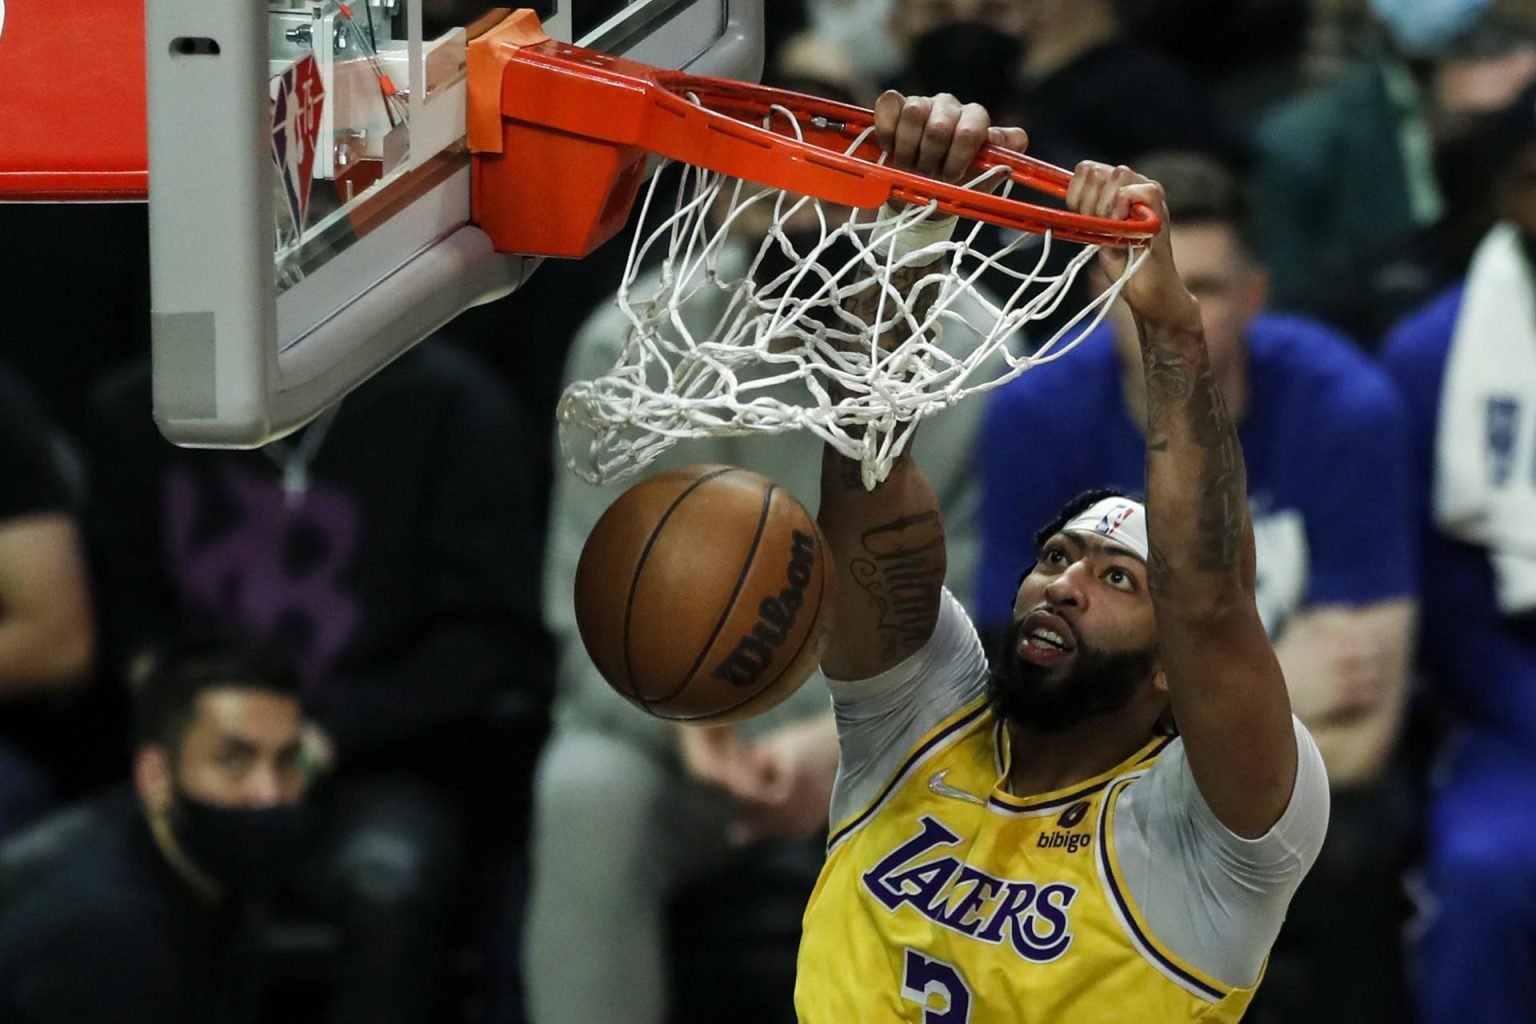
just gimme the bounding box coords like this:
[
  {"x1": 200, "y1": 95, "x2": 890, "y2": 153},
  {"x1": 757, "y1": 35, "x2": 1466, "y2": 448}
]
[{"x1": 988, "y1": 628, "x2": 1157, "y2": 734}]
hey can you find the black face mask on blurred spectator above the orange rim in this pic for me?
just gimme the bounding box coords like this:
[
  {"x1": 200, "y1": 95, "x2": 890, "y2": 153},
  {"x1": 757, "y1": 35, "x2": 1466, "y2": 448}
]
[{"x1": 902, "y1": 21, "x2": 1025, "y2": 121}]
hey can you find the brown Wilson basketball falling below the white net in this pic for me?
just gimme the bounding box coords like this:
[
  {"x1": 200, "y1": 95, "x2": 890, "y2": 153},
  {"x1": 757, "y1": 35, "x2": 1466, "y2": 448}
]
[{"x1": 576, "y1": 465, "x2": 831, "y2": 725}]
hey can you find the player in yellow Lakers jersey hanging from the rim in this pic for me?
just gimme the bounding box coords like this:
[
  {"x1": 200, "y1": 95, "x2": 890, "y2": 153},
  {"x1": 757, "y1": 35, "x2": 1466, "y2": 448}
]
[{"x1": 796, "y1": 92, "x2": 1329, "y2": 1024}]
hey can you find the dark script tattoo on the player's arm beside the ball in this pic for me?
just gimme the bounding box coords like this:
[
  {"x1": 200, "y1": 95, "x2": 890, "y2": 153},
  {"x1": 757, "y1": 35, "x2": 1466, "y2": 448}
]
[{"x1": 848, "y1": 510, "x2": 945, "y2": 657}]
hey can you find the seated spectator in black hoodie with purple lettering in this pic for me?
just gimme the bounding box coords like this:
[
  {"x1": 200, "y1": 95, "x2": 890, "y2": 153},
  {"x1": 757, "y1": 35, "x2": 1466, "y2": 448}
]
[{"x1": 91, "y1": 338, "x2": 547, "y2": 1024}]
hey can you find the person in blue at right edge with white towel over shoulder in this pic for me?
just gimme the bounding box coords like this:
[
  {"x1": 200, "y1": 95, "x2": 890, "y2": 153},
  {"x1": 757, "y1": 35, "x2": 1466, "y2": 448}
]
[{"x1": 1384, "y1": 88, "x2": 1536, "y2": 1024}]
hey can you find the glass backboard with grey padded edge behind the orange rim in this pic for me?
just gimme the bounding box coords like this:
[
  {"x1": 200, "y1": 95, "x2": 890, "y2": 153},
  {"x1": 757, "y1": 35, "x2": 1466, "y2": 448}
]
[{"x1": 146, "y1": 0, "x2": 762, "y2": 447}]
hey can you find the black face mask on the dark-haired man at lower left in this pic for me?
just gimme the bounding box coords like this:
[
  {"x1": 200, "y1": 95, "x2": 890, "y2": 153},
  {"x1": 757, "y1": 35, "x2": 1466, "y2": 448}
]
[{"x1": 170, "y1": 789, "x2": 307, "y2": 892}]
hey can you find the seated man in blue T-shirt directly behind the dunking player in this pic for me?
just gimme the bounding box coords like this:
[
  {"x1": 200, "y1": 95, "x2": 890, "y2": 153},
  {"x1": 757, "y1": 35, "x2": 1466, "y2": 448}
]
[{"x1": 975, "y1": 154, "x2": 1415, "y2": 1021}]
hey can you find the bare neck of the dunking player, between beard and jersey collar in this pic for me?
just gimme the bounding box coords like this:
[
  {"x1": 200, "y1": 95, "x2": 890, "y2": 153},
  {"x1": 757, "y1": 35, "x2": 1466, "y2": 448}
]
[{"x1": 1006, "y1": 708, "x2": 1157, "y2": 797}]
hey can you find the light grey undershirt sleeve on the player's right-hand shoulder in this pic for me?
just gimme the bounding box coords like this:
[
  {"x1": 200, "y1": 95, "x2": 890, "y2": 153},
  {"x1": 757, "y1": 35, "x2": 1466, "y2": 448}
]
[{"x1": 1114, "y1": 718, "x2": 1329, "y2": 987}]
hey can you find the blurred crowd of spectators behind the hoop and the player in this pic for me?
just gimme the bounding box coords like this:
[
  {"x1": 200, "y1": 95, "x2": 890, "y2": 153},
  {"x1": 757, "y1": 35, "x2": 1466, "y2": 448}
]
[{"x1": 0, "y1": 0, "x2": 1536, "y2": 1024}]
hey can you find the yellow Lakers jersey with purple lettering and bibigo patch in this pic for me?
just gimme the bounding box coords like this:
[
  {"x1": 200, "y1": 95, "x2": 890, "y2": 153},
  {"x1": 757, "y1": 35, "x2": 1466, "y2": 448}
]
[{"x1": 794, "y1": 700, "x2": 1253, "y2": 1024}]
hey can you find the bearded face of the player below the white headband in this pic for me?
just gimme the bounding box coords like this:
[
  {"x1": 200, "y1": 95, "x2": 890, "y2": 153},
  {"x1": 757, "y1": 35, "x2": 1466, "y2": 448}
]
[{"x1": 991, "y1": 533, "x2": 1157, "y2": 731}]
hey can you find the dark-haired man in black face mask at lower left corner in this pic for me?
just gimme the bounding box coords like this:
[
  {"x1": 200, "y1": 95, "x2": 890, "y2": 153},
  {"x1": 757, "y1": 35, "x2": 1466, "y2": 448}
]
[{"x1": 0, "y1": 643, "x2": 306, "y2": 1024}]
